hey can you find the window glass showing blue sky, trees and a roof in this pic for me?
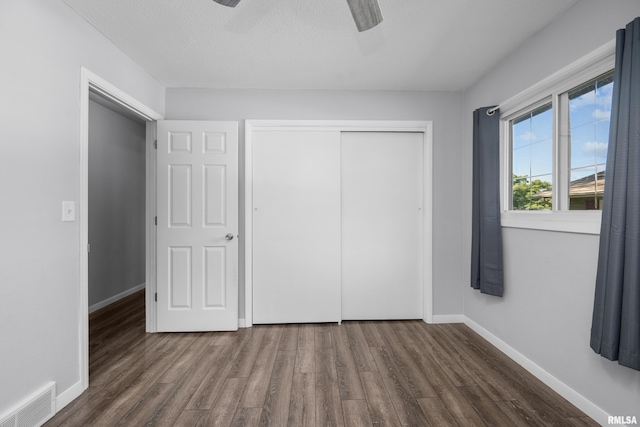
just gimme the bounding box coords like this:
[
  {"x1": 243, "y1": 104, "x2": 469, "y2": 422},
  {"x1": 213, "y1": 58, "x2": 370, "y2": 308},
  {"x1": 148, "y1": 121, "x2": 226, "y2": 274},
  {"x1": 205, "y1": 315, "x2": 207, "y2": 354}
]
[{"x1": 510, "y1": 71, "x2": 613, "y2": 211}]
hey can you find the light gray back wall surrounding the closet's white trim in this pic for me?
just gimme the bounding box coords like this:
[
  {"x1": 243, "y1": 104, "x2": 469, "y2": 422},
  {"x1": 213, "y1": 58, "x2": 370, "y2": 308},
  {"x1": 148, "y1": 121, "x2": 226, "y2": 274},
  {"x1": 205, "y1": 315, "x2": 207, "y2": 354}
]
[{"x1": 166, "y1": 89, "x2": 462, "y2": 318}]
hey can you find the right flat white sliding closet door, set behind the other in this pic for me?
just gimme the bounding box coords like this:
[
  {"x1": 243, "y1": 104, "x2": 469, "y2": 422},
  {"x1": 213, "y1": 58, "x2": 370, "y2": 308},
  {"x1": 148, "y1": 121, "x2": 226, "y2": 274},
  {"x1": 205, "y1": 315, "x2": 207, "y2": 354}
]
[{"x1": 341, "y1": 132, "x2": 424, "y2": 320}]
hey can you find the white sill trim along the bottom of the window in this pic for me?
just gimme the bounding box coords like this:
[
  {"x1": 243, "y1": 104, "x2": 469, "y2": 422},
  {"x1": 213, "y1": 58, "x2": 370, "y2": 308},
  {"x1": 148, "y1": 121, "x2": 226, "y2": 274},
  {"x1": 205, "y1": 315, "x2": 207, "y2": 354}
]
[{"x1": 500, "y1": 211, "x2": 602, "y2": 235}]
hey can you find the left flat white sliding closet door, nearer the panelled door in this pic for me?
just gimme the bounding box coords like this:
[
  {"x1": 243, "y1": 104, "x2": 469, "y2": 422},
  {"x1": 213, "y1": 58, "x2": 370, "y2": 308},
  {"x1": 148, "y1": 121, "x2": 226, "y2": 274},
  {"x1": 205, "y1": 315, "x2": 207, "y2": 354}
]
[{"x1": 252, "y1": 130, "x2": 340, "y2": 323}]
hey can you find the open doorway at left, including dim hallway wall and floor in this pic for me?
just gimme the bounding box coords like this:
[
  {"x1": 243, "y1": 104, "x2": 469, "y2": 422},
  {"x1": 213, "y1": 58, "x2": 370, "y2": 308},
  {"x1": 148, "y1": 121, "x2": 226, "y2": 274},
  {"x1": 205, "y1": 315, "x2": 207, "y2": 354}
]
[{"x1": 87, "y1": 90, "x2": 146, "y2": 381}]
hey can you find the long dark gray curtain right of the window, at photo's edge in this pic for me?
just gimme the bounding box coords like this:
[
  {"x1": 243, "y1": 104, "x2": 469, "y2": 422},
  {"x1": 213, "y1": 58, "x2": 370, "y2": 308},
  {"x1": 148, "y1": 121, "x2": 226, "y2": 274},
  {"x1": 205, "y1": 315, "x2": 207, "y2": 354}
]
[{"x1": 591, "y1": 18, "x2": 640, "y2": 370}]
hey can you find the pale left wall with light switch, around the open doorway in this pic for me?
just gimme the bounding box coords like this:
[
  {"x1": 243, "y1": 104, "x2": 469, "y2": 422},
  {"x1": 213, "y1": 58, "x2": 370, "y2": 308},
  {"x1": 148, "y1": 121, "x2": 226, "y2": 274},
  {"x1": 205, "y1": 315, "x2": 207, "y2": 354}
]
[{"x1": 0, "y1": 0, "x2": 164, "y2": 414}]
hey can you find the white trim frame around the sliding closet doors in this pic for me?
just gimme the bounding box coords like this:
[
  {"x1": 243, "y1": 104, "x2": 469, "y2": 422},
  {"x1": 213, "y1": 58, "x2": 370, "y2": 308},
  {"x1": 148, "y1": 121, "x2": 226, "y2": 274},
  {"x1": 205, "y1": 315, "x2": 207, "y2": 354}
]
[{"x1": 244, "y1": 120, "x2": 433, "y2": 327}]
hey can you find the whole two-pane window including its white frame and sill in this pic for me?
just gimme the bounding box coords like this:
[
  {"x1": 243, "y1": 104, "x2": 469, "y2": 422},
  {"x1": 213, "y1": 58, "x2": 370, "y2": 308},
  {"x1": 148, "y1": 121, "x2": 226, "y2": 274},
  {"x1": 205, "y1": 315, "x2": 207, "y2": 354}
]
[{"x1": 500, "y1": 42, "x2": 615, "y2": 234}]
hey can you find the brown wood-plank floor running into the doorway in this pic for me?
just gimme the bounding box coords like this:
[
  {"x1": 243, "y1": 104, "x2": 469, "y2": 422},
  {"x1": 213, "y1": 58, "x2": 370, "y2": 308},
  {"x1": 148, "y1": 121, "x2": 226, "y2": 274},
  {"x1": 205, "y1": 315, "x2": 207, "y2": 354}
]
[{"x1": 46, "y1": 292, "x2": 597, "y2": 427}]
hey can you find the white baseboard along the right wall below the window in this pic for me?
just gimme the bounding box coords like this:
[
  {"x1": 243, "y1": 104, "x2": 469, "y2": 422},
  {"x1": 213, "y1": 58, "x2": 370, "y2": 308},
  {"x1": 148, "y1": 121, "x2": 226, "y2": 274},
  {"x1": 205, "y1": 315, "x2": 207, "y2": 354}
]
[{"x1": 463, "y1": 316, "x2": 609, "y2": 425}]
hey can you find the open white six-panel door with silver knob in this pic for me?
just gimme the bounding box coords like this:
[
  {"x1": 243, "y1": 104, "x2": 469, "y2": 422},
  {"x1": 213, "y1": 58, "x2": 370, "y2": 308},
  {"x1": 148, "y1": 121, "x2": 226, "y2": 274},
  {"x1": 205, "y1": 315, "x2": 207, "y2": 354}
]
[{"x1": 156, "y1": 120, "x2": 238, "y2": 332}]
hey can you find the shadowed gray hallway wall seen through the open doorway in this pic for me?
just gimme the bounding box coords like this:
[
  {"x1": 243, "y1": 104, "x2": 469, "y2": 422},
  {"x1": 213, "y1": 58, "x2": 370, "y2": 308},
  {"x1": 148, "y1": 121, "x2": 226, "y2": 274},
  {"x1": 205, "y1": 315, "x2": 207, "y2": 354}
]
[{"x1": 89, "y1": 101, "x2": 146, "y2": 306}]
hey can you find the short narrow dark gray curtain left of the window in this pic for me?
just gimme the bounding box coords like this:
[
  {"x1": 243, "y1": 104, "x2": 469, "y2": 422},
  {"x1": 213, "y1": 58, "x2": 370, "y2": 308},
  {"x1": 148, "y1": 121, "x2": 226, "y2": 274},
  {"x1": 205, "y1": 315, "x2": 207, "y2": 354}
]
[{"x1": 471, "y1": 107, "x2": 503, "y2": 297}]
